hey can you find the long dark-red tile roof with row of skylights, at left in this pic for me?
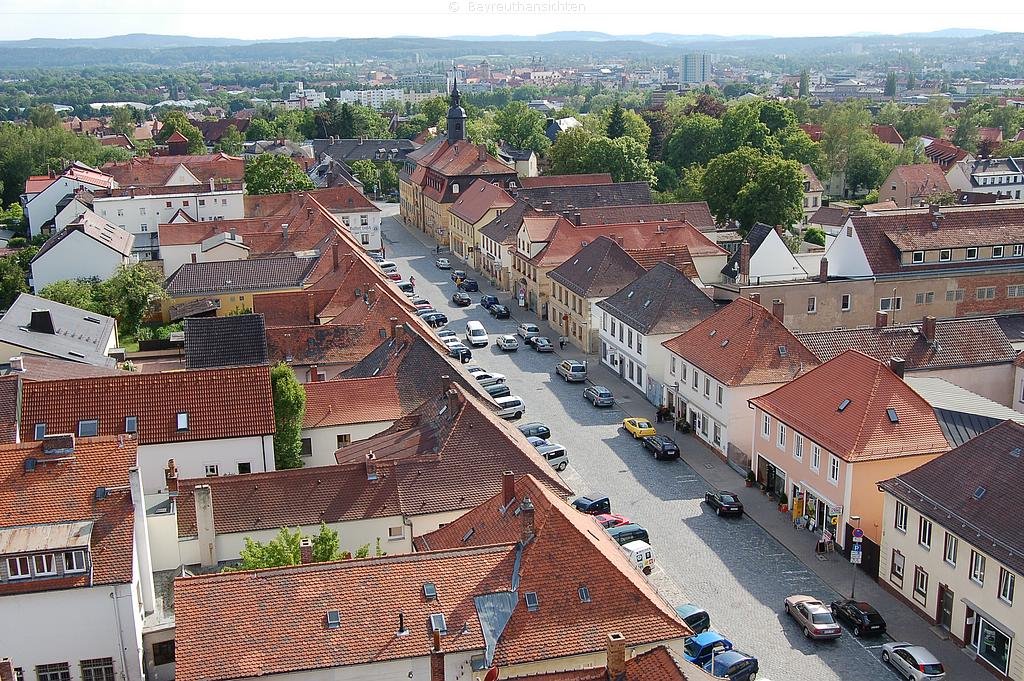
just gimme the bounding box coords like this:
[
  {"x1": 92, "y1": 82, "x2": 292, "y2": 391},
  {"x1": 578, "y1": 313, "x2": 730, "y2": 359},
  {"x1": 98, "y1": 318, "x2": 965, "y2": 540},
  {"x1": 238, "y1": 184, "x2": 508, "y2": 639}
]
[{"x1": 22, "y1": 367, "x2": 274, "y2": 444}]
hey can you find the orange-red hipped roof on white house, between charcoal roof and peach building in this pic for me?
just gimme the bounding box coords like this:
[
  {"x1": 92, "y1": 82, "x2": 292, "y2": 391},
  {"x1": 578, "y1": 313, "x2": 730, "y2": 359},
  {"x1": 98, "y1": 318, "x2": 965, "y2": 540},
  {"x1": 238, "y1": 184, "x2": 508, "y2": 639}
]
[{"x1": 662, "y1": 298, "x2": 818, "y2": 385}]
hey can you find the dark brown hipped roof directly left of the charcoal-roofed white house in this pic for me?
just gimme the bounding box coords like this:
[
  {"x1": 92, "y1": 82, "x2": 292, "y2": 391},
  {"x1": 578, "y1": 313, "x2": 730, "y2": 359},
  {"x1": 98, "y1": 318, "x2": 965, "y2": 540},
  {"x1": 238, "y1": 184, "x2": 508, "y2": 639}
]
[{"x1": 548, "y1": 237, "x2": 646, "y2": 298}]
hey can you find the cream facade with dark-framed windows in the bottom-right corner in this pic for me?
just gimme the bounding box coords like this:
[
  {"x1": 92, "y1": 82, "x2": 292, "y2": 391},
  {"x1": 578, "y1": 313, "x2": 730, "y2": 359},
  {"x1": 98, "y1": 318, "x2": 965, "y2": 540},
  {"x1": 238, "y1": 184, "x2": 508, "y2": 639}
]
[{"x1": 879, "y1": 494, "x2": 1024, "y2": 681}]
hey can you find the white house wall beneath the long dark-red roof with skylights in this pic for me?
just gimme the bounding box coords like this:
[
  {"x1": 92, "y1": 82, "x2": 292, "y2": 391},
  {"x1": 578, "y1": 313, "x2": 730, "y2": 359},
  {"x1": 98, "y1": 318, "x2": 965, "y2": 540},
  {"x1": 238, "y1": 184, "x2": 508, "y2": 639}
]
[{"x1": 138, "y1": 435, "x2": 274, "y2": 495}]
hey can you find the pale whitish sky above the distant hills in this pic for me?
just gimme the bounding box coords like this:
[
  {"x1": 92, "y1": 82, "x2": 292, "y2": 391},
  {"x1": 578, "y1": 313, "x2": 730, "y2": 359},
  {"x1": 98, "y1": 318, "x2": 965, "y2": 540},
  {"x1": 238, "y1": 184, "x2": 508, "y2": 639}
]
[{"x1": 0, "y1": 0, "x2": 1024, "y2": 40}]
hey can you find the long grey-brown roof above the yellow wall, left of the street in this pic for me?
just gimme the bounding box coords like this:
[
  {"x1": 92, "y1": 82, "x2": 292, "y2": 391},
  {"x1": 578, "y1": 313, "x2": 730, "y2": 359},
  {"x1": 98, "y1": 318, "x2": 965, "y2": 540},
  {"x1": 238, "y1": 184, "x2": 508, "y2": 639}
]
[{"x1": 166, "y1": 256, "x2": 319, "y2": 296}]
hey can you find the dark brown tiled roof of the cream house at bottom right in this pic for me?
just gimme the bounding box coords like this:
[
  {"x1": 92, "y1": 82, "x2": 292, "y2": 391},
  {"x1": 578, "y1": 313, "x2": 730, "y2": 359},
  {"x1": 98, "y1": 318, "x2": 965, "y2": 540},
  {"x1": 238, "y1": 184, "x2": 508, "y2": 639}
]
[{"x1": 879, "y1": 421, "x2": 1024, "y2": 573}]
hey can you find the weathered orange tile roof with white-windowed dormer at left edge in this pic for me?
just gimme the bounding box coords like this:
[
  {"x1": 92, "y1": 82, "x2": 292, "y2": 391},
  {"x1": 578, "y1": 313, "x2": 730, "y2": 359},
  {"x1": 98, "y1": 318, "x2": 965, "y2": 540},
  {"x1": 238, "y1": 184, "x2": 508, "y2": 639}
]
[{"x1": 0, "y1": 437, "x2": 137, "y2": 595}]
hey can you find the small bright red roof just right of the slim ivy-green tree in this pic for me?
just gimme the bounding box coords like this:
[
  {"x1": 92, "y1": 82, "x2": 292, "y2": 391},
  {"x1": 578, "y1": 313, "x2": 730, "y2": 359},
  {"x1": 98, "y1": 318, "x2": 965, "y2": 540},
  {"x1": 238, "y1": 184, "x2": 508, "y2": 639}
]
[{"x1": 302, "y1": 376, "x2": 404, "y2": 428}]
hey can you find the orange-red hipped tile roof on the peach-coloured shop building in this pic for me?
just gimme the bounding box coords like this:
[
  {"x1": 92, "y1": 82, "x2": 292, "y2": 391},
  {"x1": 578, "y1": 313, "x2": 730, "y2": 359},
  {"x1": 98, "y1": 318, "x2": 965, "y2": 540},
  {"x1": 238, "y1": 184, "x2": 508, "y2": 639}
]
[{"x1": 751, "y1": 350, "x2": 949, "y2": 461}]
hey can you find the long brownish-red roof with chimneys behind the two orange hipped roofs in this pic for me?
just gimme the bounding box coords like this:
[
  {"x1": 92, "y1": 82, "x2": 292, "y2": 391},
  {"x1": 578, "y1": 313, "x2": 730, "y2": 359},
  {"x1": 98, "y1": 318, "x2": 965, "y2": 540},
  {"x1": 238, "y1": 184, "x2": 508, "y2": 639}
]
[{"x1": 797, "y1": 317, "x2": 1016, "y2": 371}]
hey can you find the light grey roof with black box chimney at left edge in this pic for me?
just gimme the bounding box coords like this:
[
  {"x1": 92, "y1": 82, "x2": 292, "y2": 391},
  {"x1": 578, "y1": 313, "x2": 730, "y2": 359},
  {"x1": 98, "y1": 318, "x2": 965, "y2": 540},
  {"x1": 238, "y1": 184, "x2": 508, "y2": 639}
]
[{"x1": 0, "y1": 293, "x2": 116, "y2": 367}]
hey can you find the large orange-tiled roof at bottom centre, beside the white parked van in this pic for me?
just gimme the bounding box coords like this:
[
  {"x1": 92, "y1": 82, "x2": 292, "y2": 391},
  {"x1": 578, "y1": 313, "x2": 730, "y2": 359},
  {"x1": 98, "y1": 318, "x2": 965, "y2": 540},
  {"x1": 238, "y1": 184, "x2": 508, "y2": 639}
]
[{"x1": 416, "y1": 476, "x2": 691, "y2": 667}]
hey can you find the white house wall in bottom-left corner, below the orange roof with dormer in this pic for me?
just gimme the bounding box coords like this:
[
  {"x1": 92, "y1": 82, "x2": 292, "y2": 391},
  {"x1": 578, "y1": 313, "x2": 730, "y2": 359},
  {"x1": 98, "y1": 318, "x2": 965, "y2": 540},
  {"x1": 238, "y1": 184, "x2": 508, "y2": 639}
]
[{"x1": 0, "y1": 583, "x2": 142, "y2": 681}]
